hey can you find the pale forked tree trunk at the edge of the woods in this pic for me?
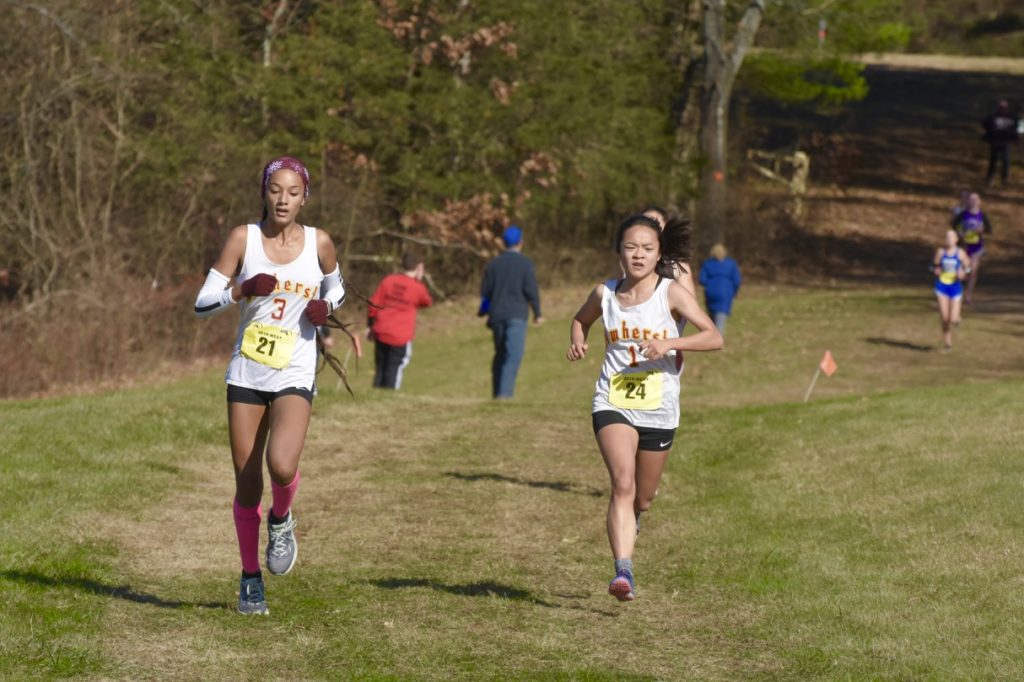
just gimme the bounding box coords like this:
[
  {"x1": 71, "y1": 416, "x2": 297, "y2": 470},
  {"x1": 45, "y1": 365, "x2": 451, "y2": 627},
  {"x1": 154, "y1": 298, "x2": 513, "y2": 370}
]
[{"x1": 697, "y1": 0, "x2": 767, "y2": 251}]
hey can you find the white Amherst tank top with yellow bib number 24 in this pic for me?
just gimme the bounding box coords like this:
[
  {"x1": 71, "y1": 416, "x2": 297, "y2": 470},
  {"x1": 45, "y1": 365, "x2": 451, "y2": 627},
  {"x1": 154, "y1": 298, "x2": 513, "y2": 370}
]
[{"x1": 592, "y1": 279, "x2": 682, "y2": 429}]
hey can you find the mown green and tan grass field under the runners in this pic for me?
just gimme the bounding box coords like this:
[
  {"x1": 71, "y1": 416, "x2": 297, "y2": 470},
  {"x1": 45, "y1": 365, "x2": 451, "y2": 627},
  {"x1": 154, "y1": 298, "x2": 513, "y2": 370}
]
[{"x1": 0, "y1": 286, "x2": 1024, "y2": 680}]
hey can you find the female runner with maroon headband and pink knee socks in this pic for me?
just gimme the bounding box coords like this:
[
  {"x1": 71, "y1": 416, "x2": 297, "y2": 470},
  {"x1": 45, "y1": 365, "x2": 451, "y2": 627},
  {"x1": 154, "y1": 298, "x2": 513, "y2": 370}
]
[{"x1": 196, "y1": 157, "x2": 345, "y2": 614}]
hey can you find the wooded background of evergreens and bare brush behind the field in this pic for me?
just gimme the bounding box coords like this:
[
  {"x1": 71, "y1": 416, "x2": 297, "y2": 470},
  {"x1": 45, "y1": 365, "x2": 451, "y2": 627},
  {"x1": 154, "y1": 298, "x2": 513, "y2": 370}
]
[{"x1": 0, "y1": 0, "x2": 1024, "y2": 396}]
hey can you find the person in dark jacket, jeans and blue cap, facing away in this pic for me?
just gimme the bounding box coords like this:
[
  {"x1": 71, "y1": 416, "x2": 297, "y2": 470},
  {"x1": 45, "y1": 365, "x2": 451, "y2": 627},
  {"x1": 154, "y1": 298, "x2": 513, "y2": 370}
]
[{"x1": 478, "y1": 225, "x2": 544, "y2": 399}]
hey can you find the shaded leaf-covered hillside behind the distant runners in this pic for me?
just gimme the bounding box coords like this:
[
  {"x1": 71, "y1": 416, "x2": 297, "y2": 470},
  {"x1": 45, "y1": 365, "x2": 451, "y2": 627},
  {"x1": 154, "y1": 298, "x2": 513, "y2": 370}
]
[{"x1": 741, "y1": 55, "x2": 1024, "y2": 289}]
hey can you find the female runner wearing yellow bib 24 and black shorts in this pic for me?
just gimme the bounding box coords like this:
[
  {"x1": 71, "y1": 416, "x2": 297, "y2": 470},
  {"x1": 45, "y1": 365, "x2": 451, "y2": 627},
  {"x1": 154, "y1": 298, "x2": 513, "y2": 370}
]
[{"x1": 565, "y1": 215, "x2": 722, "y2": 601}]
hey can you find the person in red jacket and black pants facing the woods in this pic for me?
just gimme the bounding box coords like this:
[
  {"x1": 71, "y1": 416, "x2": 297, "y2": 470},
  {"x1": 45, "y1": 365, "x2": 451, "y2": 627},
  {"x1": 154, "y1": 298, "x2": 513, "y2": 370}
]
[{"x1": 367, "y1": 253, "x2": 434, "y2": 389}]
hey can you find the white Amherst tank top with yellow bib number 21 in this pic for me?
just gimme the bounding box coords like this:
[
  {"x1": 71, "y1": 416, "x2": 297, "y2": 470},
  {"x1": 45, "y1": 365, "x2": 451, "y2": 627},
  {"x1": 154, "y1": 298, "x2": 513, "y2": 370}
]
[{"x1": 224, "y1": 224, "x2": 324, "y2": 392}]
